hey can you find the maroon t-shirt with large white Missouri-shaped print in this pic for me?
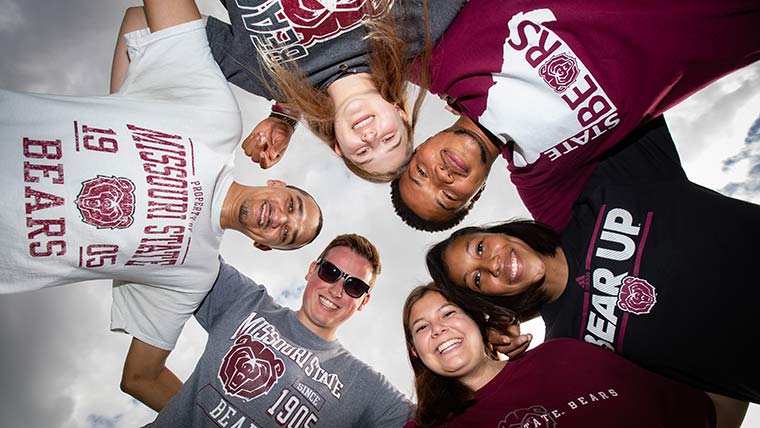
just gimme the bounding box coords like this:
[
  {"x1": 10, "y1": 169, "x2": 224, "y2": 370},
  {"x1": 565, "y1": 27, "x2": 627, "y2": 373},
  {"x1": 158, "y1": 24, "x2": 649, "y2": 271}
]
[{"x1": 430, "y1": 0, "x2": 760, "y2": 230}]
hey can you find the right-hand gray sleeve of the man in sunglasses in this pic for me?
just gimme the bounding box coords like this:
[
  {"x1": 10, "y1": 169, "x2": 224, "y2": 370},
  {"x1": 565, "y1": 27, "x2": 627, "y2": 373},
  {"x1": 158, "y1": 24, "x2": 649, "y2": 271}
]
[{"x1": 360, "y1": 369, "x2": 414, "y2": 428}]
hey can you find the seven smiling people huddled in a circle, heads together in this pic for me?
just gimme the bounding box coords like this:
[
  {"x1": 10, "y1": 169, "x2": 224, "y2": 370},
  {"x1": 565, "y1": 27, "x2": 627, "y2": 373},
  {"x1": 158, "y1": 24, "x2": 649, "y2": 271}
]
[{"x1": 0, "y1": 0, "x2": 760, "y2": 427}]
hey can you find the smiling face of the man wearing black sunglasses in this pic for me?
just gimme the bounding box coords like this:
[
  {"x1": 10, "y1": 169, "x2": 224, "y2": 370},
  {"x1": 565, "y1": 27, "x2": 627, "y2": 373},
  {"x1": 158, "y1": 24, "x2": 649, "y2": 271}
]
[{"x1": 298, "y1": 247, "x2": 373, "y2": 340}]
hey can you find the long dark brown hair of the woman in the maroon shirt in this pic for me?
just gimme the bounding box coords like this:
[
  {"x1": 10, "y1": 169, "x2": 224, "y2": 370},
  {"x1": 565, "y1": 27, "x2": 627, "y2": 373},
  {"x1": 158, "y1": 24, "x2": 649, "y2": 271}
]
[{"x1": 402, "y1": 282, "x2": 498, "y2": 428}]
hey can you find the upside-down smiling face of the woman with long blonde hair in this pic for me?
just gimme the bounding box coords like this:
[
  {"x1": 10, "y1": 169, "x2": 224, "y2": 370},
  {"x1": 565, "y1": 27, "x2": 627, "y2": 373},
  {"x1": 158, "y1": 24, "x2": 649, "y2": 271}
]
[{"x1": 335, "y1": 94, "x2": 412, "y2": 173}]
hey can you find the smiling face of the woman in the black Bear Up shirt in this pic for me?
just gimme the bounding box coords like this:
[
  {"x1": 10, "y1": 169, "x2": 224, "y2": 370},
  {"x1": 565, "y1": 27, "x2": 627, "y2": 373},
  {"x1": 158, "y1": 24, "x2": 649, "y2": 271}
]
[{"x1": 443, "y1": 233, "x2": 546, "y2": 296}]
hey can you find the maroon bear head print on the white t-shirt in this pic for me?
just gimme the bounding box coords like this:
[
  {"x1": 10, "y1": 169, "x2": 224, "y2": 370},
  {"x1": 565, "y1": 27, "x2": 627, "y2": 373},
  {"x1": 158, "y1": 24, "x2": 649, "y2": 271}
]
[{"x1": 74, "y1": 175, "x2": 135, "y2": 229}]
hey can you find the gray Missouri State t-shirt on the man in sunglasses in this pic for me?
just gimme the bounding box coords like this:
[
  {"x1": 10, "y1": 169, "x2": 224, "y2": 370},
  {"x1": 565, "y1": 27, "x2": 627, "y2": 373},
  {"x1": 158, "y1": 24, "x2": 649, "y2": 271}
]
[{"x1": 148, "y1": 263, "x2": 412, "y2": 428}]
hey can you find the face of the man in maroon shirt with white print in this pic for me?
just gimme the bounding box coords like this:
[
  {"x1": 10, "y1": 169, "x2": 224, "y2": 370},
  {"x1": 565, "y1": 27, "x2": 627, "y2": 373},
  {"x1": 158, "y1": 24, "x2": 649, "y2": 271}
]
[{"x1": 399, "y1": 130, "x2": 491, "y2": 222}]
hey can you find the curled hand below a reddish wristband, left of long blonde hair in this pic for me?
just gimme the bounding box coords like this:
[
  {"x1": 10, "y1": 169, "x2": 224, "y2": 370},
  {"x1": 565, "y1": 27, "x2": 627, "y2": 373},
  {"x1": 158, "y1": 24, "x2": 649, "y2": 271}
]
[{"x1": 243, "y1": 117, "x2": 293, "y2": 169}]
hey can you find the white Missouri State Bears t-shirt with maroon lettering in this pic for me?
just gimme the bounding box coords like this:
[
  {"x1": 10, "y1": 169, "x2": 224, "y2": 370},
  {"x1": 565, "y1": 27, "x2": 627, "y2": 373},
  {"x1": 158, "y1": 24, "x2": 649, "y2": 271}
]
[{"x1": 0, "y1": 20, "x2": 242, "y2": 348}]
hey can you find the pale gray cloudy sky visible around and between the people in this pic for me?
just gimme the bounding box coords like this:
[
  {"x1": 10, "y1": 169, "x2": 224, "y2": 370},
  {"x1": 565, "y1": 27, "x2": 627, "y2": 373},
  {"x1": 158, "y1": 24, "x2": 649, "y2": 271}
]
[{"x1": 0, "y1": 0, "x2": 760, "y2": 428}]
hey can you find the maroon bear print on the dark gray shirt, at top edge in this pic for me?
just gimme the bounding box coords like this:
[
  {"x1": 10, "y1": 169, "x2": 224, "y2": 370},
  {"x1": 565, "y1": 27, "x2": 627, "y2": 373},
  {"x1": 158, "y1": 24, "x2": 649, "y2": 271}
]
[{"x1": 281, "y1": 0, "x2": 382, "y2": 47}]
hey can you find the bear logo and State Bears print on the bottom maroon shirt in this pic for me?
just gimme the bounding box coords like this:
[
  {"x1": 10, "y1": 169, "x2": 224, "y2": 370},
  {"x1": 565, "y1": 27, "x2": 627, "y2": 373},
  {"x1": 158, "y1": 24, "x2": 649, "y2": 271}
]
[{"x1": 497, "y1": 388, "x2": 620, "y2": 428}]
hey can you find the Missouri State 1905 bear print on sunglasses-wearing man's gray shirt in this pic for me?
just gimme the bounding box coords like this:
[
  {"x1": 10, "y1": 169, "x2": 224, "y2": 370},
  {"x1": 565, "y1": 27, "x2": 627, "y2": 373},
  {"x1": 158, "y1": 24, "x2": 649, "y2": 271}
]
[{"x1": 196, "y1": 312, "x2": 344, "y2": 428}]
